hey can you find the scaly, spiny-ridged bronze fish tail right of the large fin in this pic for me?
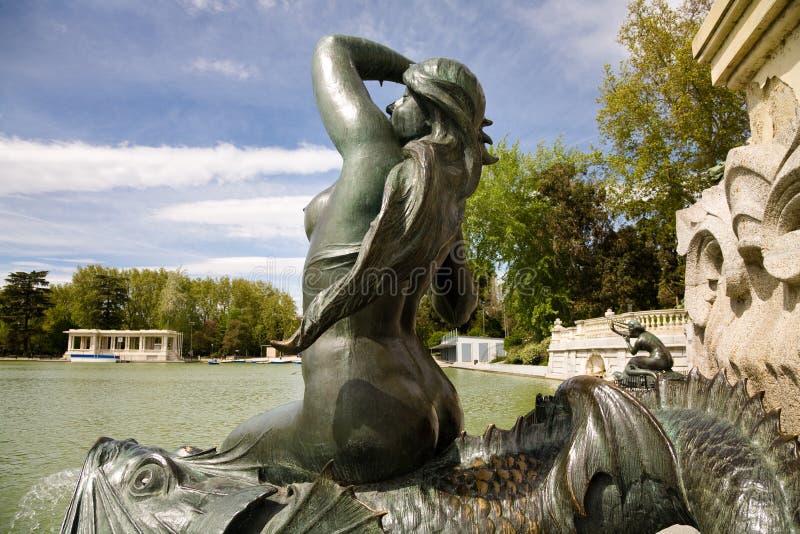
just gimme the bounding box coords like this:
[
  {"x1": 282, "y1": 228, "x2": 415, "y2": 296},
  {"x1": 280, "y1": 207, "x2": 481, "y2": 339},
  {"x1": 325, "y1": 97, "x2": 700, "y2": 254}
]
[{"x1": 653, "y1": 369, "x2": 800, "y2": 533}]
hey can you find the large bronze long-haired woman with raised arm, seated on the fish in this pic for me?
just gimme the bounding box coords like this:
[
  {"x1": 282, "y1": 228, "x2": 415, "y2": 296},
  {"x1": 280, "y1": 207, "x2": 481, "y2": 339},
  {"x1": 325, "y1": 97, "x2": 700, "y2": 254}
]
[{"x1": 216, "y1": 36, "x2": 494, "y2": 483}]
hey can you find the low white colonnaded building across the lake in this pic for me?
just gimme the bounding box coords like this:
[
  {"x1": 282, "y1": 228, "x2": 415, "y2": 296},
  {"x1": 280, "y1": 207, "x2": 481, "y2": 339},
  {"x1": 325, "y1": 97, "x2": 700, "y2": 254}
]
[{"x1": 64, "y1": 329, "x2": 183, "y2": 363}]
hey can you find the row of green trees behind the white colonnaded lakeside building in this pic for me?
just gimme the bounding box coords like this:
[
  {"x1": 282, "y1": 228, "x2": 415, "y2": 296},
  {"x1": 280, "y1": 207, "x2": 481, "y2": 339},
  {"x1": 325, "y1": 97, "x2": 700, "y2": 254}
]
[{"x1": 30, "y1": 265, "x2": 299, "y2": 355}]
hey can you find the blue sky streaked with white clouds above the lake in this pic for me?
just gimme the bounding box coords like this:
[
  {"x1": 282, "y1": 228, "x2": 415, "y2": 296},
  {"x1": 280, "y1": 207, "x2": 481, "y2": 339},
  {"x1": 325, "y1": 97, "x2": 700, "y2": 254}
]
[{"x1": 0, "y1": 0, "x2": 648, "y2": 308}]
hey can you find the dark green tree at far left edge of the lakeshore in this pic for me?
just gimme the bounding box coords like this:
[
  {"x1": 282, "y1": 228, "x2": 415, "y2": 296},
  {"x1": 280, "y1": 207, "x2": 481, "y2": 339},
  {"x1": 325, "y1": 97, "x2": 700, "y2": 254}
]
[{"x1": 0, "y1": 271, "x2": 51, "y2": 356}]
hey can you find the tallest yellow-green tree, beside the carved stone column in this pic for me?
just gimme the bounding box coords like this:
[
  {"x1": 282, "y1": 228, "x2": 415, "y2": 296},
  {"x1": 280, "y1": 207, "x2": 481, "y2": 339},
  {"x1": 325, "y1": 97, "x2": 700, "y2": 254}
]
[{"x1": 597, "y1": 0, "x2": 749, "y2": 306}]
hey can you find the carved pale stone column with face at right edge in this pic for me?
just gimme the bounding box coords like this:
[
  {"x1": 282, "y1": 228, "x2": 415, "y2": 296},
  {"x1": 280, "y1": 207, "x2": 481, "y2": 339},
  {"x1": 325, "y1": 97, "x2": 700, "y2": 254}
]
[{"x1": 677, "y1": 0, "x2": 800, "y2": 433}]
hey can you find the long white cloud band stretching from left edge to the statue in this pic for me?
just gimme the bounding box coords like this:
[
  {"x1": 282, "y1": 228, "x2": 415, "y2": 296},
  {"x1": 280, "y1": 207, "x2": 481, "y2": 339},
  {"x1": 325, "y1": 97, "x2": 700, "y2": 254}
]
[{"x1": 0, "y1": 137, "x2": 342, "y2": 196}]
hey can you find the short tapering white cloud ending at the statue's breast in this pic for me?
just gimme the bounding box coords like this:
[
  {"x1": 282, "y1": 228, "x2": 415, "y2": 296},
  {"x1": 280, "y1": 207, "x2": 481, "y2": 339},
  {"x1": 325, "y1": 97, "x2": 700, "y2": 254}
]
[{"x1": 153, "y1": 196, "x2": 311, "y2": 239}]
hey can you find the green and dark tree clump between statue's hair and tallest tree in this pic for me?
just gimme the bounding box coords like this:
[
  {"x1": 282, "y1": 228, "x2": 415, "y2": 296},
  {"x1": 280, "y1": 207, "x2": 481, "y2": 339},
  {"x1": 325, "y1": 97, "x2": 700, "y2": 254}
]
[{"x1": 464, "y1": 141, "x2": 658, "y2": 345}]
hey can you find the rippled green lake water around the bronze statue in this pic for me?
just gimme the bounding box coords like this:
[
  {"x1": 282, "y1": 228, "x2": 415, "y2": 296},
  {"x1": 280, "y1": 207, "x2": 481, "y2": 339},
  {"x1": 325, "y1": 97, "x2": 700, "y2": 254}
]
[{"x1": 0, "y1": 362, "x2": 558, "y2": 533}]
